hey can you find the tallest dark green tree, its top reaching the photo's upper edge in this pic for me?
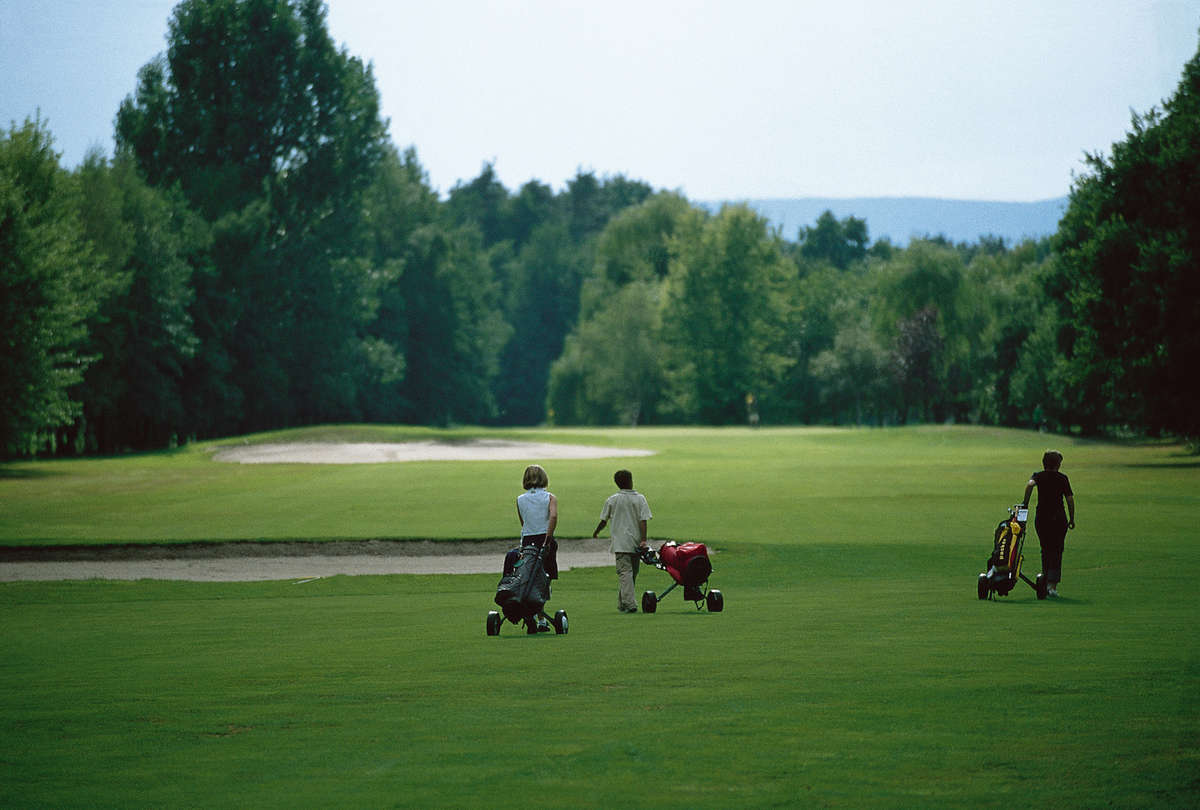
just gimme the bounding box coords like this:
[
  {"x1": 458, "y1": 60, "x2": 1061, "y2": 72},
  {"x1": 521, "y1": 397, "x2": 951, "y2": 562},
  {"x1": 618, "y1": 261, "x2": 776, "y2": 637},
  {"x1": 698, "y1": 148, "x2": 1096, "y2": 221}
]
[{"x1": 116, "y1": 0, "x2": 386, "y2": 431}]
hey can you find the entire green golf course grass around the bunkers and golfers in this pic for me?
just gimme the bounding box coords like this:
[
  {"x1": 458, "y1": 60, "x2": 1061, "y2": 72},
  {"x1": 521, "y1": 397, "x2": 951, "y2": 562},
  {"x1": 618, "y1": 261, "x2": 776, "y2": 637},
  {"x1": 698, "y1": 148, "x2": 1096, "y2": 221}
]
[{"x1": 0, "y1": 427, "x2": 1200, "y2": 808}]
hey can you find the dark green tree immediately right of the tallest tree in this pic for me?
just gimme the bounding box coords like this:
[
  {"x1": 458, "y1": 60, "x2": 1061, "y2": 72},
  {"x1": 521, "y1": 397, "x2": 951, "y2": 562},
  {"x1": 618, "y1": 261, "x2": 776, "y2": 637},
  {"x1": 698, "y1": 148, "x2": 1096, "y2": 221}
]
[{"x1": 361, "y1": 150, "x2": 510, "y2": 425}]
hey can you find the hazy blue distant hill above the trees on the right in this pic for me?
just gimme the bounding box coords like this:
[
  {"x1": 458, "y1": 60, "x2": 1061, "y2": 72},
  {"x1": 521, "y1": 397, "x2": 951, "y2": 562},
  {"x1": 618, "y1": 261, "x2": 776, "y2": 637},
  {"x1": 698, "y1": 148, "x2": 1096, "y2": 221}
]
[{"x1": 701, "y1": 197, "x2": 1068, "y2": 246}]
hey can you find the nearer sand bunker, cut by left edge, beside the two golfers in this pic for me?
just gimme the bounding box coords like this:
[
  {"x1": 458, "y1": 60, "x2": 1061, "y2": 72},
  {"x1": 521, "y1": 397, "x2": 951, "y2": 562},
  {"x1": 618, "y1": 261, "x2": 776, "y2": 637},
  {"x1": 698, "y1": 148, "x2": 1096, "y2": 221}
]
[{"x1": 0, "y1": 538, "x2": 613, "y2": 582}]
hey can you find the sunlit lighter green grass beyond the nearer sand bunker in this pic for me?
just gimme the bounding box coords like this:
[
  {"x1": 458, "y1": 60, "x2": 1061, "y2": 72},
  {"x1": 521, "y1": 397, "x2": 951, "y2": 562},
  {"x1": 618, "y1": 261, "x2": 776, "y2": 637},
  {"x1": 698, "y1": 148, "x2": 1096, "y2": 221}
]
[{"x1": 0, "y1": 426, "x2": 1200, "y2": 545}]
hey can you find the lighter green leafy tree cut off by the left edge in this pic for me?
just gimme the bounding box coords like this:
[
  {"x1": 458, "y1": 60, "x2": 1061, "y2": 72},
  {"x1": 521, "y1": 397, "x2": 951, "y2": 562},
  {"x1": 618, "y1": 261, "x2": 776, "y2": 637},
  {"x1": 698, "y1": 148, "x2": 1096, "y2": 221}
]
[{"x1": 0, "y1": 120, "x2": 108, "y2": 455}]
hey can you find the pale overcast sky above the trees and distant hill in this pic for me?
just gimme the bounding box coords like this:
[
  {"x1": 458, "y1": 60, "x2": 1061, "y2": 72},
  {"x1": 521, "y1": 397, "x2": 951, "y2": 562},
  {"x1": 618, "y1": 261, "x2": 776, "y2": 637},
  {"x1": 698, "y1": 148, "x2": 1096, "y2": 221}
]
[{"x1": 0, "y1": 0, "x2": 1200, "y2": 202}]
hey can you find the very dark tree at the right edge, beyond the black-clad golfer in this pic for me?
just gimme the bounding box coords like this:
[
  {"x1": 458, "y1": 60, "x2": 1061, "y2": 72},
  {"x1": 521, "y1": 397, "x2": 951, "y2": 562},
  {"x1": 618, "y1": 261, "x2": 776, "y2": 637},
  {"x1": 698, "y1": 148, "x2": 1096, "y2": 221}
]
[{"x1": 1050, "y1": 40, "x2": 1200, "y2": 439}]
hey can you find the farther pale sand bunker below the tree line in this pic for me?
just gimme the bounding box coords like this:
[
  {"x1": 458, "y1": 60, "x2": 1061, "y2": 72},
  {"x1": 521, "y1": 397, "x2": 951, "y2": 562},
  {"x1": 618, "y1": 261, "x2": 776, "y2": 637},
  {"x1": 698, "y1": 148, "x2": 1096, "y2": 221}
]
[{"x1": 212, "y1": 439, "x2": 654, "y2": 464}]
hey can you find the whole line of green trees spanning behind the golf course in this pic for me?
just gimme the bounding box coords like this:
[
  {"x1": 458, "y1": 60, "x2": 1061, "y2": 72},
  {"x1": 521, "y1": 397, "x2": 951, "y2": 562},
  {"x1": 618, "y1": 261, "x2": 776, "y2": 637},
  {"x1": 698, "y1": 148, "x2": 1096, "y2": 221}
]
[{"x1": 0, "y1": 0, "x2": 1200, "y2": 456}]
